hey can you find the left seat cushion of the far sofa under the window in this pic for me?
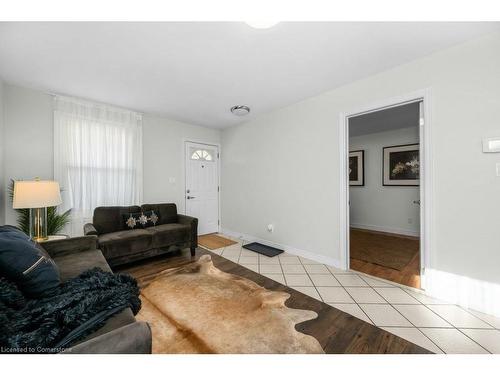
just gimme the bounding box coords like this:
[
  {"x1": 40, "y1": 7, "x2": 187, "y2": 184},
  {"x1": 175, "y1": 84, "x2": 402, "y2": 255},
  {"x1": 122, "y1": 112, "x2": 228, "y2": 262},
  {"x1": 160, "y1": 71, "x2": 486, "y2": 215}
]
[{"x1": 98, "y1": 228, "x2": 153, "y2": 259}]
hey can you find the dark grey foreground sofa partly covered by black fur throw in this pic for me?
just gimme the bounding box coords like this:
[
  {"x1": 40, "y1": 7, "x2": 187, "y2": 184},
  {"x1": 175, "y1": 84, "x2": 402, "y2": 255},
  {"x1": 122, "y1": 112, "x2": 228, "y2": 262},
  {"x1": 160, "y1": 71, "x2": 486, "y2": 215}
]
[{"x1": 42, "y1": 236, "x2": 152, "y2": 354}]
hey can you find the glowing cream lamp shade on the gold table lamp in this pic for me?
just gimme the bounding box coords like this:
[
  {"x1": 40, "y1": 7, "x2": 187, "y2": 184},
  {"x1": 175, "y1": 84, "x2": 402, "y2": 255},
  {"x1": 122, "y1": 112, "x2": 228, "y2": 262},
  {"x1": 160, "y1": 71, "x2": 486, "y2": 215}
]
[{"x1": 12, "y1": 181, "x2": 62, "y2": 209}]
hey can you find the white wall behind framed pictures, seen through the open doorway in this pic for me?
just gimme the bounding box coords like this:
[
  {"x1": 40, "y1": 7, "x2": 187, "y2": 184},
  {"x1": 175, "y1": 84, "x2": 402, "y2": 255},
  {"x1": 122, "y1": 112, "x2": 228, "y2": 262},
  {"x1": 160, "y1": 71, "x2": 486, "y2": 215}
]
[{"x1": 349, "y1": 125, "x2": 420, "y2": 236}]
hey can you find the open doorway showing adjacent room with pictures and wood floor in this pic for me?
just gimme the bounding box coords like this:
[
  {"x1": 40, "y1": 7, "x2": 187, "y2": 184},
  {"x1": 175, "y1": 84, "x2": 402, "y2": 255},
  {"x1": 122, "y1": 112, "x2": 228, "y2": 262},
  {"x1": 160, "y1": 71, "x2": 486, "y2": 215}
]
[{"x1": 346, "y1": 99, "x2": 424, "y2": 288}]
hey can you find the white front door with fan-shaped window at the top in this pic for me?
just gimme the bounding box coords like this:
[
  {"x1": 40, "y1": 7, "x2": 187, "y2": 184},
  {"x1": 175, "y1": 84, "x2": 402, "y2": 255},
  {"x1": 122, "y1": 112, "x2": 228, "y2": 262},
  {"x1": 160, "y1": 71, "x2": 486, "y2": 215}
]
[{"x1": 185, "y1": 142, "x2": 219, "y2": 235}]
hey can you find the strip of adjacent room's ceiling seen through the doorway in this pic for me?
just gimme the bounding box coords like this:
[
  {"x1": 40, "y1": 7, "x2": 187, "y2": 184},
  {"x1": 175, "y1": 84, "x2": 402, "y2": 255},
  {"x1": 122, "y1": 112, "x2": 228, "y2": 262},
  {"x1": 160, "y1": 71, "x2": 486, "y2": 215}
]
[{"x1": 349, "y1": 103, "x2": 420, "y2": 137}]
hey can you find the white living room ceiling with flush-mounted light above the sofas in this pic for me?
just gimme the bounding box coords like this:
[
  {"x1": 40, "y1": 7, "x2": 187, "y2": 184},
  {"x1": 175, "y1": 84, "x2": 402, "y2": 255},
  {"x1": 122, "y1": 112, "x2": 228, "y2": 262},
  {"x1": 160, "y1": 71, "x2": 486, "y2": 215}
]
[{"x1": 0, "y1": 22, "x2": 500, "y2": 128}]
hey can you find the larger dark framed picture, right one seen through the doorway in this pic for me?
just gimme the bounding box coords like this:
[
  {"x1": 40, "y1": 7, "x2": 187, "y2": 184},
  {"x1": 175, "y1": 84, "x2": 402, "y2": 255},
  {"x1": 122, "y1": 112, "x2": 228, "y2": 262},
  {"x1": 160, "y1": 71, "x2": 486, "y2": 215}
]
[{"x1": 382, "y1": 143, "x2": 420, "y2": 186}]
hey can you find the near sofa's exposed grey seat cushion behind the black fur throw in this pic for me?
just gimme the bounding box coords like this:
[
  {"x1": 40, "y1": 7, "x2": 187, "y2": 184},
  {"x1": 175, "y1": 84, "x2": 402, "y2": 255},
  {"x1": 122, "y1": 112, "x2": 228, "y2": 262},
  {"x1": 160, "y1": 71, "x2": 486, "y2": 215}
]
[{"x1": 54, "y1": 250, "x2": 111, "y2": 281}]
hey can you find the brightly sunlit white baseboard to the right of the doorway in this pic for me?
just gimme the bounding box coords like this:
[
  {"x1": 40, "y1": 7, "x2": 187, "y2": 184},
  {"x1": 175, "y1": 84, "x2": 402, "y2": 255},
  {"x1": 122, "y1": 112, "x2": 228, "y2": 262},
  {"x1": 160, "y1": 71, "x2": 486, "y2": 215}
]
[{"x1": 425, "y1": 268, "x2": 500, "y2": 317}]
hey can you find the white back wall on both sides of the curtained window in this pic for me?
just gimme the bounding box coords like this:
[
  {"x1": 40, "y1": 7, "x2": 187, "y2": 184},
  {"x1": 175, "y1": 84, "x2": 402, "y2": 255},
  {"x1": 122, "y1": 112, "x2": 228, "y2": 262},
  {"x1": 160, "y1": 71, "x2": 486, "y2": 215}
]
[{"x1": 3, "y1": 84, "x2": 220, "y2": 224}]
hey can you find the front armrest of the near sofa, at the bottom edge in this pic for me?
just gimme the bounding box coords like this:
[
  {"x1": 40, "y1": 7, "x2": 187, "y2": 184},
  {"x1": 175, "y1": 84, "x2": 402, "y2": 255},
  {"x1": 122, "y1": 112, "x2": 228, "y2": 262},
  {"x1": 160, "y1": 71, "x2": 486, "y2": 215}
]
[{"x1": 62, "y1": 322, "x2": 152, "y2": 354}]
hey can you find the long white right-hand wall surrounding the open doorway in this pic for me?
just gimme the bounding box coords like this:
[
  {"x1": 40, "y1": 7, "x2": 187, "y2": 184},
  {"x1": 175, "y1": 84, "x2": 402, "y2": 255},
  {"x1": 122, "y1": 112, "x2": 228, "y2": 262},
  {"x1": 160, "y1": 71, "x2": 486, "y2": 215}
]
[{"x1": 222, "y1": 33, "x2": 500, "y2": 306}]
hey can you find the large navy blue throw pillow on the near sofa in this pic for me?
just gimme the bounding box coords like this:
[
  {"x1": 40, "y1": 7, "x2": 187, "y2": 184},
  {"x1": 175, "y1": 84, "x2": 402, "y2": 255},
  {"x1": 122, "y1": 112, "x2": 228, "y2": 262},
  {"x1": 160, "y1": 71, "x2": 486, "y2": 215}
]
[{"x1": 0, "y1": 226, "x2": 60, "y2": 298}]
